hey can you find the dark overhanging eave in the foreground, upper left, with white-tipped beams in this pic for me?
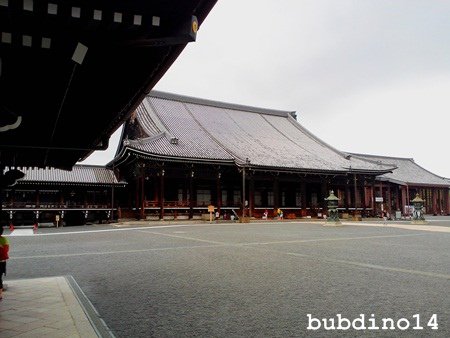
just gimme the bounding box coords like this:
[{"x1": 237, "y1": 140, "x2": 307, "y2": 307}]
[{"x1": 0, "y1": 0, "x2": 216, "y2": 168}]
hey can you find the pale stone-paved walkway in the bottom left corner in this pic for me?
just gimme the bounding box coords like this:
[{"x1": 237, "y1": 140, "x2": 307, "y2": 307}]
[{"x1": 0, "y1": 276, "x2": 113, "y2": 338}]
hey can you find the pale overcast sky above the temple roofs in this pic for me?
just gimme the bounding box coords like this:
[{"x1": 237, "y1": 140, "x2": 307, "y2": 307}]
[{"x1": 83, "y1": 0, "x2": 450, "y2": 177}]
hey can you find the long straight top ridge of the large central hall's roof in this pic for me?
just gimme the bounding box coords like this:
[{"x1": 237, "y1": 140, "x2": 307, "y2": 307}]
[{"x1": 147, "y1": 90, "x2": 296, "y2": 116}]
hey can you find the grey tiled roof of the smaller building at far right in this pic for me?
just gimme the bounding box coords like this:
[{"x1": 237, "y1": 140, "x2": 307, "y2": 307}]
[{"x1": 352, "y1": 154, "x2": 450, "y2": 187}]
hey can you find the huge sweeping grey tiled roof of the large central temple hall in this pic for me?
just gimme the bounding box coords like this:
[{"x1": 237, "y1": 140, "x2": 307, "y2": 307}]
[{"x1": 115, "y1": 91, "x2": 394, "y2": 173}]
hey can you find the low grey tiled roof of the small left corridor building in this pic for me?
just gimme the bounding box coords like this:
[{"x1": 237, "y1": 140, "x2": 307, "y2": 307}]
[{"x1": 8, "y1": 165, "x2": 125, "y2": 185}]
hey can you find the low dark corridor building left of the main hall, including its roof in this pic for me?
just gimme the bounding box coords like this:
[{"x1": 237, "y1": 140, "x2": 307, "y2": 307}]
[{"x1": 1, "y1": 165, "x2": 126, "y2": 225}]
